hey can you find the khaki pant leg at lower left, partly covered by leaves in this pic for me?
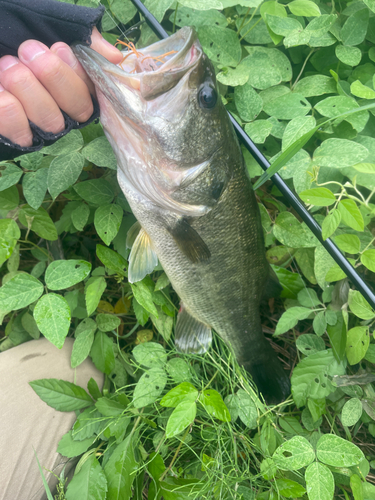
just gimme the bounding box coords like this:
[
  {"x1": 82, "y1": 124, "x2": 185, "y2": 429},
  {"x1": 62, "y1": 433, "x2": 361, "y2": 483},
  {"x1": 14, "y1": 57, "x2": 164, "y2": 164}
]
[{"x1": 0, "y1": 338, "x2": 104, "y2": 500}]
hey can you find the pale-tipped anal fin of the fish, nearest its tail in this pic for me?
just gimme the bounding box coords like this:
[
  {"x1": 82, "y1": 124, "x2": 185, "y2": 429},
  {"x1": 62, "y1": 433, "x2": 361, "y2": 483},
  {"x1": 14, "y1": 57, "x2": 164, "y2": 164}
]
[{"x1": 175, "y1": 306, "x2": 212, "y2": 354}]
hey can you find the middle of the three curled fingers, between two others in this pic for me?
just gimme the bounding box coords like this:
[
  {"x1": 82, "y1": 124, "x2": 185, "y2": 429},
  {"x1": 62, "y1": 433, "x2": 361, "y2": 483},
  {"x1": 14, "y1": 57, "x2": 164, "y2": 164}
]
[{"x1": 0, "y1": 56, "x2": 65, "y2": 134}]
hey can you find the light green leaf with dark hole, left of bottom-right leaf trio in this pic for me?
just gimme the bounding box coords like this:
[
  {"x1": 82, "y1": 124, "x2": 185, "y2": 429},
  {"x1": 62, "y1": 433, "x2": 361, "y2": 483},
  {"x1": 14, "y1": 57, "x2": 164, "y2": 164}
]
[{"x1": 272, "y1": 436, "x2": 315, "y2": 470}]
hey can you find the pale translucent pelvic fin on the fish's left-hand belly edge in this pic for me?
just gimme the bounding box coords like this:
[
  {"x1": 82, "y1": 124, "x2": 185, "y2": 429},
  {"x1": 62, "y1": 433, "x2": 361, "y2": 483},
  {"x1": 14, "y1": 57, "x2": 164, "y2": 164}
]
[{"x1": 128, "y1": 224, "x2": 158, "y2": 283}]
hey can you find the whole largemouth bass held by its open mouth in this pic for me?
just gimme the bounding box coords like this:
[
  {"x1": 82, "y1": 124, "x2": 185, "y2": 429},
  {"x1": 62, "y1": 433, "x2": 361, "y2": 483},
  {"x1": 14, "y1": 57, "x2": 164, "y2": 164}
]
[{"x1": 74, "y1": 28, "x2": 290, "y2": 403}]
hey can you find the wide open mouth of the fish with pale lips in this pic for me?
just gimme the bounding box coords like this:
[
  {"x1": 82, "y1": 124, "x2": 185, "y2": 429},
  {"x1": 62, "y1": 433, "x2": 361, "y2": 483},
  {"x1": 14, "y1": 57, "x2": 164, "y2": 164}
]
[{"x1": 72, "y1": 27, "x2": 203, "y2": 104}]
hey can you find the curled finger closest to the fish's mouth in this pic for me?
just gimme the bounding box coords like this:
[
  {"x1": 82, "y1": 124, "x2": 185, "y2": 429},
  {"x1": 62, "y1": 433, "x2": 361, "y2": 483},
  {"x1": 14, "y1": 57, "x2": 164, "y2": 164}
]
[{"x1": 18, "y1": 40, "x2": 94, "y2": 122}]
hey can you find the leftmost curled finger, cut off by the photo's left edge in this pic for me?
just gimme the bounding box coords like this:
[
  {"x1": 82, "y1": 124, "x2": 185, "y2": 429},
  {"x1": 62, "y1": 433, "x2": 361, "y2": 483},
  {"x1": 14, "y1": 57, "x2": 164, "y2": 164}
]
[{"x1": 0, "y1": 85, "x2": 33, "y2": 147}]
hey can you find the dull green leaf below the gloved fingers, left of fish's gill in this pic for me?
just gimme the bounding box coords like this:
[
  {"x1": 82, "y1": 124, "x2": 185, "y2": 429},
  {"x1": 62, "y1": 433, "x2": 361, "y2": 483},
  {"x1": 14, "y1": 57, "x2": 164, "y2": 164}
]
[{"x1": 47, "y1": 151, "x2": 84, "y2": 198}]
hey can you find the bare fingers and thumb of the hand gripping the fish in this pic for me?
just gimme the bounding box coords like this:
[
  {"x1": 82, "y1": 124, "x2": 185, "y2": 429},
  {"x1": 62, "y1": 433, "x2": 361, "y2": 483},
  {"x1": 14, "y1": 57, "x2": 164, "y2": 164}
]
[{"x1": 0, "y1": 28, "x2": 122, "y2": 147}]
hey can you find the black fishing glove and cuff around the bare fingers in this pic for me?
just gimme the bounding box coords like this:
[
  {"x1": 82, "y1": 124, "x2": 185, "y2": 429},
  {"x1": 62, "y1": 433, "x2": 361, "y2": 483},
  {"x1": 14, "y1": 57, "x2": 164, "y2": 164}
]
[{"x1": 0, "y1": 0, "x2": 105, "y2": 161}]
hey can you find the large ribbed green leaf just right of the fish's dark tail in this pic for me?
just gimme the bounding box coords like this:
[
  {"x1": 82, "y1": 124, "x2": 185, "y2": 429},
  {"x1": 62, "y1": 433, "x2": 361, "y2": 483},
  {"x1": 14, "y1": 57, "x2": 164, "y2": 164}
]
[{"x1": 291, "y1": 349, "x2": 345, "y2": 408}]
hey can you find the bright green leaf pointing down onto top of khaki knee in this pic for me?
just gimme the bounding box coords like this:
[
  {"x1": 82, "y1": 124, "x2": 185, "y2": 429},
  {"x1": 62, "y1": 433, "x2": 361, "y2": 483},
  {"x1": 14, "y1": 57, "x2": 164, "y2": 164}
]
[{"x1": 34, "y1": 293, "x2": 70, "y2": 349}]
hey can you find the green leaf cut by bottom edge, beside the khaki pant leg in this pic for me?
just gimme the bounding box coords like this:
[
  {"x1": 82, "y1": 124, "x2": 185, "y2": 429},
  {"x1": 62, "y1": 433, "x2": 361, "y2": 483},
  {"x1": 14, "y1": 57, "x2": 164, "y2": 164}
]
[{"x1": 65, "y1": 455, "x2": 107, "y2": 500}]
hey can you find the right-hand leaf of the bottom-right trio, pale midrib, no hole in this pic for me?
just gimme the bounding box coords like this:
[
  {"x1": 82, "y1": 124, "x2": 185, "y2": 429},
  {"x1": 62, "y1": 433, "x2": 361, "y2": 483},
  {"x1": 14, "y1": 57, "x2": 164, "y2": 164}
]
[{"x1": 316, "y1": 434, "x2": 365, "y2": 467}]
